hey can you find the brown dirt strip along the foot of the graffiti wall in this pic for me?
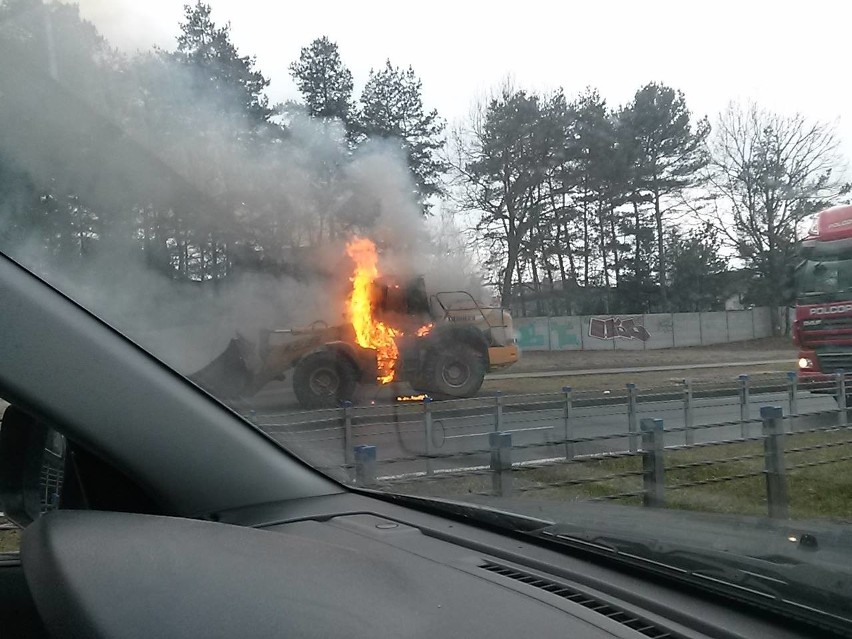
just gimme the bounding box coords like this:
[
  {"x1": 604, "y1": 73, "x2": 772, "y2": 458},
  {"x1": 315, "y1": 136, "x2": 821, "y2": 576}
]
[{"x1": 510, "y1": 337, "x2": 796, "y2": 373}]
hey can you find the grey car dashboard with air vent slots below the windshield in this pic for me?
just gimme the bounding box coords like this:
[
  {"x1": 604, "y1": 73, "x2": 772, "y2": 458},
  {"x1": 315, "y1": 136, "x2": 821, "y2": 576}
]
[{"x1": 22, "y1": 494, "x2": 832, "y2": 639}]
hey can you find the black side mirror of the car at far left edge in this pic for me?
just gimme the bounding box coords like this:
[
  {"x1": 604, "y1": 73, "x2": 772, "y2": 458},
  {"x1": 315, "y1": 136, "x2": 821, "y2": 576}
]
[{"x1": 0, "y1": 406, "x2": 65, "y2": 528}]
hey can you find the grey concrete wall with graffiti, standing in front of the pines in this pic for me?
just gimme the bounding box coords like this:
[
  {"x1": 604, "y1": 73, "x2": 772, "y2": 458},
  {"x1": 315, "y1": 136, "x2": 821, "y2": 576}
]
[{"x1": 515, "y1": 308, "x2": 775, "y2": 351}]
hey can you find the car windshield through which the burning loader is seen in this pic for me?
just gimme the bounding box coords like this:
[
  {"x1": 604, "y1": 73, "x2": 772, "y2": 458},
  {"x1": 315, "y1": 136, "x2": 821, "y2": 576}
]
[{"x1": 0, "y1": 0, "x2": 852, "y2": 632}]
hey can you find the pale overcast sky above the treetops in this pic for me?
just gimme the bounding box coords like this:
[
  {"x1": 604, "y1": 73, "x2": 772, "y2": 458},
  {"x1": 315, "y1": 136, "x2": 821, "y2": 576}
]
[{"x1": 68, "y1": 0, "x2": 852, "y2": 158}]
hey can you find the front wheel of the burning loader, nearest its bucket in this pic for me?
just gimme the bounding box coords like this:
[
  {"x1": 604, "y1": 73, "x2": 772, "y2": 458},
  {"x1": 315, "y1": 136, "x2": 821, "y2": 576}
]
[{"x1": 293, "y1": 351, "x2": 358, "y2": 408}]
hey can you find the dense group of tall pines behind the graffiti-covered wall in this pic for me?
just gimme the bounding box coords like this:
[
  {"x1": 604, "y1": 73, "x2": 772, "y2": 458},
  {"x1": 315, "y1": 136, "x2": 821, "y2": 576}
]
[{"x1": 457, "y1": 84, "x2": 709, "y2": 315}]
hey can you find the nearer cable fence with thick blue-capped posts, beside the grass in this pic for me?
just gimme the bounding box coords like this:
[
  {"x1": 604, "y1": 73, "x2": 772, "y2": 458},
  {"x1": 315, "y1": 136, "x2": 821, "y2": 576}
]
[{"x1": 354, "y1": 406, "x2": 852, "y2": 518}]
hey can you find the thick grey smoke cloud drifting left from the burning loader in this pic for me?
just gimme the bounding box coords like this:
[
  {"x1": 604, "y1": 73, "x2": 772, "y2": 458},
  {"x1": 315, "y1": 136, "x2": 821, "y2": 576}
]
[{"x1": 0, "y1": 6, "x2": 480, "y2": 372}]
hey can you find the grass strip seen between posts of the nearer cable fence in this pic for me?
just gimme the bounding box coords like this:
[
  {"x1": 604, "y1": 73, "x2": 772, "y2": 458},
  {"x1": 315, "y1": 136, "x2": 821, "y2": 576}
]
[{"x1": 388, "y1": 429, "x2": 852, "y2": 521}]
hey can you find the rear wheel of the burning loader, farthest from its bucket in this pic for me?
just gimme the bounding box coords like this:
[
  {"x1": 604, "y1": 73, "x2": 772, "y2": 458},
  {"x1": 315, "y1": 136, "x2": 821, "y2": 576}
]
[{"x1": 417, "y1": 343, "x2": 485, "y2": 399}]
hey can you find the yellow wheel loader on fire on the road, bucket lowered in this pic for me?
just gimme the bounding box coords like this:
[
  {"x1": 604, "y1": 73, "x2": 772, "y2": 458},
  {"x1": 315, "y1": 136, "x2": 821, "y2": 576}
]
[{"x1": 190, "y1": 285, "x2": 519, "y2": 408}]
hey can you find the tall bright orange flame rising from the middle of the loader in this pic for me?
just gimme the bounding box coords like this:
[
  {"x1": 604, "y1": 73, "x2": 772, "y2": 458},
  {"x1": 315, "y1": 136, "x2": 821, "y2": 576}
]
[{"x1": 346, "y1": 237, "x2": 402, "y2": 384}]
